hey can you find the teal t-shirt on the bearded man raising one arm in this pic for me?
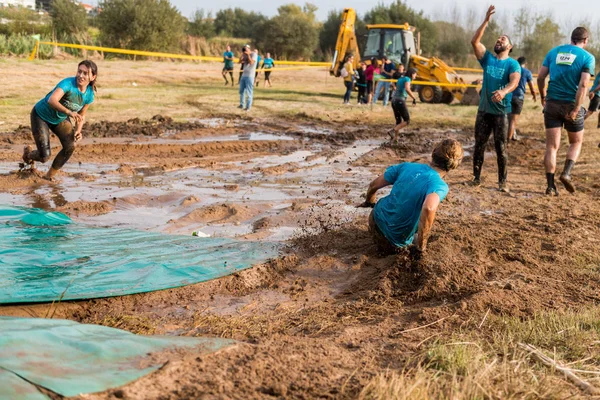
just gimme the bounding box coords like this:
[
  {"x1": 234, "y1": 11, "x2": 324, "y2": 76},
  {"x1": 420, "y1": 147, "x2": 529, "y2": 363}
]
[{"x1": 479, "y1": 50, "x2": 521, "y2": 115}]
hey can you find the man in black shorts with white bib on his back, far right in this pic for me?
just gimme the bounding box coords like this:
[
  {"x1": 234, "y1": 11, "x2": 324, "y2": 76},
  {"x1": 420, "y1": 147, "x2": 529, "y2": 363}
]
[{"x1": 538, "y1": 27, "x2": 596, "y2": 196}]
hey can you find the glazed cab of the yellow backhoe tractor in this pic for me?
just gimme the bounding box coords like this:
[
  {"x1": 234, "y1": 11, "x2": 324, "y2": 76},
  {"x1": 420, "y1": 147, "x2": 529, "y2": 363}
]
[{"x1": 363, "y1": 24, "x2": 418, "y2": 68}]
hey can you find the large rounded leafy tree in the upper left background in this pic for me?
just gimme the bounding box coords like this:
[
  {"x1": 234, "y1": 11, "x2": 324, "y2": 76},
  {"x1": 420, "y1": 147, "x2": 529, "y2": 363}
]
[{"x1": 98, "y1": 0, "x2": 186, "y2": 51}]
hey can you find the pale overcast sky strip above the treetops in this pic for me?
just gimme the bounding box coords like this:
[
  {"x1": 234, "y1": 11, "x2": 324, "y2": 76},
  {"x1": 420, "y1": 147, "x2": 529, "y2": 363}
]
[{"x1": 189, "y1": 0, "x2": 600, "y2": 24}]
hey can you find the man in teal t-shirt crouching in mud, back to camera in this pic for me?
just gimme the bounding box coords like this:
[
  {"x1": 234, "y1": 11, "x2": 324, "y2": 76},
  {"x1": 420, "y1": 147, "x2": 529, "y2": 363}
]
[{"x1": 359, "y1": 139, "x2": 464, "y2": 259}]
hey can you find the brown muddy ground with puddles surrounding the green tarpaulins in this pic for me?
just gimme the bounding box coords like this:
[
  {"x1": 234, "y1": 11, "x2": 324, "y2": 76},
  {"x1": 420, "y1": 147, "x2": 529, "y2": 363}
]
[{"x1": 0, "y1": 60, "x2": 600, "y2": 399}]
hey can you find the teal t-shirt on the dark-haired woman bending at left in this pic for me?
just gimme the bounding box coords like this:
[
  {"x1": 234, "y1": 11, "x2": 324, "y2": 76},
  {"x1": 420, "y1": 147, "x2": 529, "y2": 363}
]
[{"x1": 35, "y1": 77, "x2": 94, "y2": 125}]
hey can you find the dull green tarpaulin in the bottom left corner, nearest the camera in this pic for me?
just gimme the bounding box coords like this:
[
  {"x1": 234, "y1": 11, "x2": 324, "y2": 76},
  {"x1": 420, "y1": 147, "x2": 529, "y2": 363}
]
[{"x1": 0, "y1": 317, "x2": 235, "y2": 400}]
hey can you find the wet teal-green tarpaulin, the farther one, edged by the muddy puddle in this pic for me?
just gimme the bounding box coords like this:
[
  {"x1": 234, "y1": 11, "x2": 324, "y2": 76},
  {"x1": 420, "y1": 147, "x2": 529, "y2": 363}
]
[{"x1": 0, "y1": 206, "x2": 278, "y2": 304}]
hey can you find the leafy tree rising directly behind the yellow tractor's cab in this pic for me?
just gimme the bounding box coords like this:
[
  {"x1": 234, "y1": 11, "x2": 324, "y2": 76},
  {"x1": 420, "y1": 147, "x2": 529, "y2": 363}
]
[{"x1": 364, "y1": 0, "x2": 438, "y2": 54}]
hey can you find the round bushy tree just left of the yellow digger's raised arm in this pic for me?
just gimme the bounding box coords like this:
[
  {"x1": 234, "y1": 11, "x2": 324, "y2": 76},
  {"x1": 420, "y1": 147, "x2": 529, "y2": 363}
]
[{"x1": 254, "y1": 3, "x2": 321, "y2": 59}]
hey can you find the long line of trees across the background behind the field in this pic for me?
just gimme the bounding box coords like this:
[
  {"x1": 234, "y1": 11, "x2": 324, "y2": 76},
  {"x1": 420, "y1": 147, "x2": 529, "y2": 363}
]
[{"x1": 0, "y1": 0, "x2": 600, "y2": 69}]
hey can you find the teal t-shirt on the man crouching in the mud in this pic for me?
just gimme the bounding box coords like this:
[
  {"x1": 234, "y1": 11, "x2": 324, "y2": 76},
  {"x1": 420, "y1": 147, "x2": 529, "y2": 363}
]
[{"x1": 373, "y1": 163, "x2": 448, "y2": 247}]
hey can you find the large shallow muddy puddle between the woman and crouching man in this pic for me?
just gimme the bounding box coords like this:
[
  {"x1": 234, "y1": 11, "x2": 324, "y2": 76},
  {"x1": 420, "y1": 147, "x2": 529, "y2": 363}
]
[{"x1": 0, "y1": 140, "x2": 380, "y2": 241}]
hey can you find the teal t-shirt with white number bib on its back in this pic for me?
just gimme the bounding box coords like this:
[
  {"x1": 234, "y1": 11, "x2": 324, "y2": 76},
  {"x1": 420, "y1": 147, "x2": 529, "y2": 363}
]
[{"x1": 542, "y1": 44, "x2": 596, "y2": 102}]
